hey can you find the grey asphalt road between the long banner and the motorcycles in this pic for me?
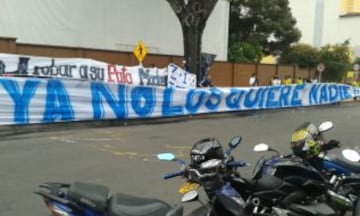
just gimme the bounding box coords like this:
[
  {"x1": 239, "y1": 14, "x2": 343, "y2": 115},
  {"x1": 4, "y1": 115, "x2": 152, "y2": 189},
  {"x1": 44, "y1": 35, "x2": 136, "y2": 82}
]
[{"x1": 0, "y1": 102, "x2": 360, "y2": 216}]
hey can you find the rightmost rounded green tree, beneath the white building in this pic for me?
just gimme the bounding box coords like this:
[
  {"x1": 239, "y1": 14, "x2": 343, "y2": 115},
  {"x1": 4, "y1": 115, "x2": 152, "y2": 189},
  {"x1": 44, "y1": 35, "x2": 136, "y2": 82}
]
[{"x1": 320, "y1": 44, "x2": 351, "y2": 82}]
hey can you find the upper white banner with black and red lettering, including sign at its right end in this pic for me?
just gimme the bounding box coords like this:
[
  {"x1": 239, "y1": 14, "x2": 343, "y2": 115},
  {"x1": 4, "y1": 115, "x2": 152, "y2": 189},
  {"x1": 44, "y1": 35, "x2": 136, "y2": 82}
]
[{"x1": 0, "y1": 54, "x2": 196, "y2": 88}]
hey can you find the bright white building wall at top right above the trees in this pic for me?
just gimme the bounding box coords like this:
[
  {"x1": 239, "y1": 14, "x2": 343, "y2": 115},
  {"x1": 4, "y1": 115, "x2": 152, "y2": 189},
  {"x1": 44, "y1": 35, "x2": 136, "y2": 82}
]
[{"x1": 289, "y1": 0, "x2": 360, "y2": 56}]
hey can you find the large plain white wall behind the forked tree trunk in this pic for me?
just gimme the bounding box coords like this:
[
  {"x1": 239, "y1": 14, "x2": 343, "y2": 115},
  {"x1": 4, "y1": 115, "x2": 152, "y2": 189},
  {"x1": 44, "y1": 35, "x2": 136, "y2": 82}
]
[{"x1": 0, "y1": 0, "x2": 229, "y2": 60}]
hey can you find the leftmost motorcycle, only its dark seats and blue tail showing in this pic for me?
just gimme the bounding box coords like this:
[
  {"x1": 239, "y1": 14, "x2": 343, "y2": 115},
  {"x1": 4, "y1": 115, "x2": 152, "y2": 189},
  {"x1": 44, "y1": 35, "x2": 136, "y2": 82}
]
[{"x1": 35, "y1": 182, "x2": 184, "y2": 216}]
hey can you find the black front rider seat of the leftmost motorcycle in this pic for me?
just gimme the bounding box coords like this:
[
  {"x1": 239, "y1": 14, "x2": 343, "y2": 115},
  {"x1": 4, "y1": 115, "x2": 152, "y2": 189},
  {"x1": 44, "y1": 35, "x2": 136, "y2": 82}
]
[{"x1": 108, "y1": 193, "x2": 183, "y2": 216}]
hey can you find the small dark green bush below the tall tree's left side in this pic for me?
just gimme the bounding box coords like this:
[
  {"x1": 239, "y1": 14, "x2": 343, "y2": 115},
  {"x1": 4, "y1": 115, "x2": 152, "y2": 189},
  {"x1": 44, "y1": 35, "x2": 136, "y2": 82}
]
[{"x1": 229, "y1": 42, "x2": 262, "y2": 63}]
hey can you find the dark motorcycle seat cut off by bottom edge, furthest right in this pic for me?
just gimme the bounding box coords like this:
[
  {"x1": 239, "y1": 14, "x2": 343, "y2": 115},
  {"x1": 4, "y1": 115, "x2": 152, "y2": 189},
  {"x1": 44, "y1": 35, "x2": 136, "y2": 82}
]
[{"x1": 289, "y1": 203, "x2": 337, "y2": 216}]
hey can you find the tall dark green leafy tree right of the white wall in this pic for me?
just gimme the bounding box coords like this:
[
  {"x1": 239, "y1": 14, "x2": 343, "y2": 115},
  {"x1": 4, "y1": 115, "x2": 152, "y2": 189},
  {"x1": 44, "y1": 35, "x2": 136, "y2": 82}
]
[{"x1": 229, "y1": 0, "x2": 301, "y2": 62}]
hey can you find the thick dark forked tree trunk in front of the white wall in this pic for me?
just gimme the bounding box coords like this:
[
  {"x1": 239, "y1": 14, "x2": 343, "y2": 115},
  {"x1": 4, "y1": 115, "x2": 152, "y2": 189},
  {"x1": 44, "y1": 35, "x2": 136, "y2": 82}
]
[{"x1": 167, "y1": 0, "x2": 218, "y2": 83}]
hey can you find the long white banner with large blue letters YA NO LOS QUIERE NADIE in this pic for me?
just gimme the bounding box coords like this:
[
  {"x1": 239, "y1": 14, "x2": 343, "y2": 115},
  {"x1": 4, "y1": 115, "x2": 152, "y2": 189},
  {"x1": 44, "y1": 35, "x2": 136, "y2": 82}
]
[{"x1": 0, "y1": 77, "x2": 360, "y2": 125}]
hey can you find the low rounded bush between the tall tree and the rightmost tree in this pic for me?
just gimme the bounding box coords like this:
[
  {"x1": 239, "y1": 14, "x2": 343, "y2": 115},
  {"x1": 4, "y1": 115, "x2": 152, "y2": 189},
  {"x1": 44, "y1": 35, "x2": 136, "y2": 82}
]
[{"x1": 279, "y1": 44, "x2": 320, "y2": 68}]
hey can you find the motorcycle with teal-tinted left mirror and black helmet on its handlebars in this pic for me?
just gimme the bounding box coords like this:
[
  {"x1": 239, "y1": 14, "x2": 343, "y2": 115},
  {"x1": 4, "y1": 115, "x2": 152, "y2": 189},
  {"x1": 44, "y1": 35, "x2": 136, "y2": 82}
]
[{"x1": 157, "y1": 137, "x2": 250, "y2": 216}]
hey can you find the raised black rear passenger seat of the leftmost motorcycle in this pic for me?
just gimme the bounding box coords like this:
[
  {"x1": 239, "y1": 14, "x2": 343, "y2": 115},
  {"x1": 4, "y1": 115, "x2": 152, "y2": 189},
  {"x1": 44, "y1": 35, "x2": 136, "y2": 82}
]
[{"x1": 68, "y1": 182, "x2": 109, "y2": 212}]
